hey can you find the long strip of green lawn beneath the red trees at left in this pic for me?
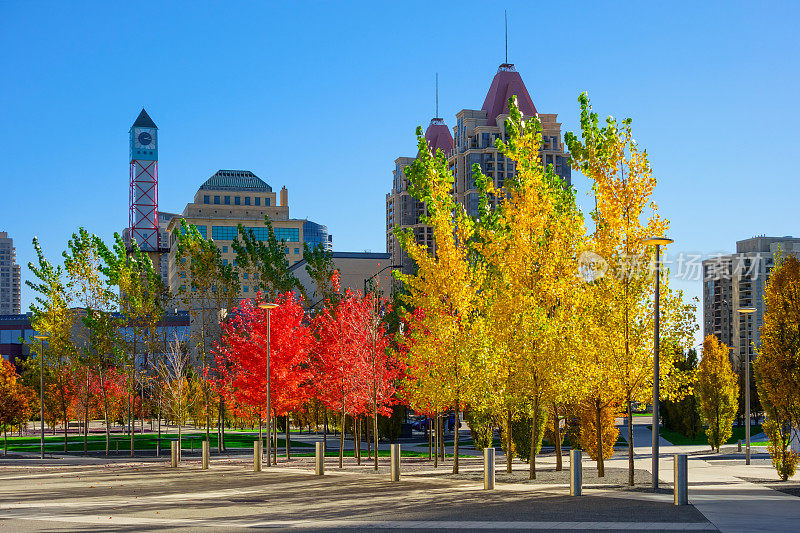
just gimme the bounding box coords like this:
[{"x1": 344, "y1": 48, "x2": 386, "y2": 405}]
[{"x1": 0, "y1": 432, "x2": 313, "y2": 453}]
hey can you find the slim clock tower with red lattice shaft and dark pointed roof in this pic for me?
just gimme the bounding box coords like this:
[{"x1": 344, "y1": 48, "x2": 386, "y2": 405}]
[{"x1": 128, "y1": 109, "x2": 159, "y2": 254}]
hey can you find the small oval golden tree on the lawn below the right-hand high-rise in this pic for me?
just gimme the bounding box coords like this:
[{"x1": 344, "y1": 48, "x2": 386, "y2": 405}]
[{"x1": 695, "y1": 335, "x2": 739, "y2": 452}]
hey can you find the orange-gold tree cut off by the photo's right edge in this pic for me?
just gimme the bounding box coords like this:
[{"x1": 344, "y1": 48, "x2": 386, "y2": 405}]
[{"x1": 753, "y1": 251, "x2": 800, "y2": 481}]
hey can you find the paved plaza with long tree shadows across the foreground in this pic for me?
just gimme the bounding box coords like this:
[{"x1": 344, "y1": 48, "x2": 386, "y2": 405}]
[{"x1": 0, "y1": 421, "x2": 800, "y2": 532}]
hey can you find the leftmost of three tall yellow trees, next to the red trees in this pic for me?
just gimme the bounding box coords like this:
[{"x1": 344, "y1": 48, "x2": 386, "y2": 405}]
[{"x1": 397, "y1": 128, "x2": 481, "y2": 474}]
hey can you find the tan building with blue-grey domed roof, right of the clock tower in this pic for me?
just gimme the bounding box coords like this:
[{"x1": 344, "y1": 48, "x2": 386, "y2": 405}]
[{"x1": 167, "y1": 170, "x2": 330, "y2": 298}]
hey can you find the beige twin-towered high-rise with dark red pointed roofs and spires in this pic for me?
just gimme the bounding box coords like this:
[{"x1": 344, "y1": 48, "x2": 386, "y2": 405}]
[{"x1": 386, "y1": 63, "x2": 571, "y2": 273}]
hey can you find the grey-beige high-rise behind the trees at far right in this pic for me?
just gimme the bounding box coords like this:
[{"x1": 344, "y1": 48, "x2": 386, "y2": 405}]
[{"x1": 703, "y1": 236, "x2": 800, "y2": 369}]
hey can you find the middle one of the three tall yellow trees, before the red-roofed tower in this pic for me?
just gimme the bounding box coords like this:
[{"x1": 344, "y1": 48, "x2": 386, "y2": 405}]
[{"x1": 474, "y1": 98, "x2": 584, "y2": 479}]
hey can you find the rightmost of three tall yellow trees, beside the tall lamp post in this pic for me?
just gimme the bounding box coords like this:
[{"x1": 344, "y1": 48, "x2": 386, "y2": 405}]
[{"x1": 565, "y1": 93, "x2": 693, "y2": 485}]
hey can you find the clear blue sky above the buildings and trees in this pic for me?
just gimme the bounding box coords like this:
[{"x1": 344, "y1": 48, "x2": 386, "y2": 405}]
[{"x1": 0, "y1": 0, "x2": 800, "y2": 320}]
